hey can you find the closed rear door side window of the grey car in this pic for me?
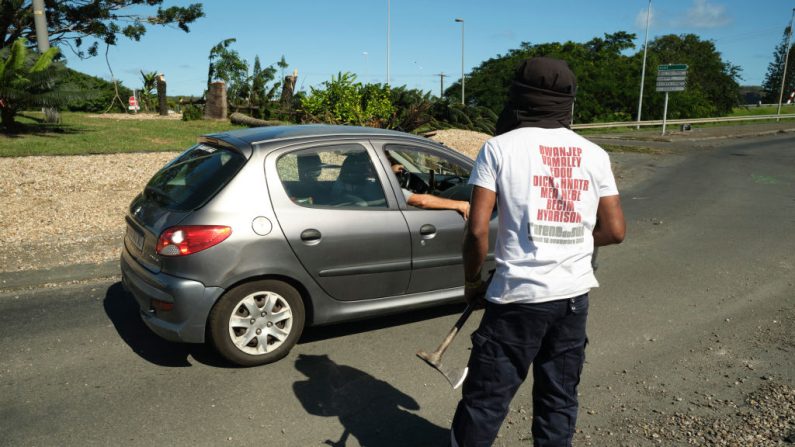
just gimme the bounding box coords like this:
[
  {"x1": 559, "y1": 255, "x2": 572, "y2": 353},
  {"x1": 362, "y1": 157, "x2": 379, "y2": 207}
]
[{"x1": 276, "y1": 144, "x2": 387, "y2": 208}]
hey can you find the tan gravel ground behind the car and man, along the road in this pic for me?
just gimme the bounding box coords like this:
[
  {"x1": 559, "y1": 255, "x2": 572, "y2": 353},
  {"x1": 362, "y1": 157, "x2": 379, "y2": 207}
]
[{"x1": 0, "y1": 130, "x2": 681, "y2": 273}]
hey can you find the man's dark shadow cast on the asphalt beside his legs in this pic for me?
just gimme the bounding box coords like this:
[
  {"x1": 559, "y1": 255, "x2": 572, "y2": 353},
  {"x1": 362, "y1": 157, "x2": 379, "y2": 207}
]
[{"x1": 293, "y1": 354, "x2": 450, "y2": 447}]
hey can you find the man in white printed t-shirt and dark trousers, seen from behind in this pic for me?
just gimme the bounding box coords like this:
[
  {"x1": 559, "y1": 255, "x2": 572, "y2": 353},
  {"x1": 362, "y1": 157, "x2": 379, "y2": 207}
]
[{"x1": 451, "y1": 58, "x2": 625, "y2": 446}]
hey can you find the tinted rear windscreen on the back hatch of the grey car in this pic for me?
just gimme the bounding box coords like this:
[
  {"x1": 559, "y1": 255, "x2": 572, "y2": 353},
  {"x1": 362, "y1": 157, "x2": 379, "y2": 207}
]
[{"x1": 144, "y1": 144, "x2": 246, "y2": 211}]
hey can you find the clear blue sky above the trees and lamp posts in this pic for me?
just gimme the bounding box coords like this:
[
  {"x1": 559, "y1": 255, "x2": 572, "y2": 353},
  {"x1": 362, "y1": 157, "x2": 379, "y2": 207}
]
[{"x1": 64, "y1": 0, "x2": 795, "y2": 96}]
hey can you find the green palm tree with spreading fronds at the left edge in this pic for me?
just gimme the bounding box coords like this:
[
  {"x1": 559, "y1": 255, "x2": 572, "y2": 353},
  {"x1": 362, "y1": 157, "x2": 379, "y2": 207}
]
[{"x1": 0, "y1": 39, "x2": 66, "y2": 131}]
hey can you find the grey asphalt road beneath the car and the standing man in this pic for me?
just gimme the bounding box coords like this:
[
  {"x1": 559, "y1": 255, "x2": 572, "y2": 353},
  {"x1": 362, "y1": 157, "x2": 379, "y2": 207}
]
[{"x1": 0, "y1": 135, "x2": 795, "y2": 446}]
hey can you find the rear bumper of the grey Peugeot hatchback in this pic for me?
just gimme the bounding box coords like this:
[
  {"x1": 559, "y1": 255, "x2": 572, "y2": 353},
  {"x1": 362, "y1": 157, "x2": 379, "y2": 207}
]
[{"x1": 120, "y1": 248, "x2": 224, "y2": 343}]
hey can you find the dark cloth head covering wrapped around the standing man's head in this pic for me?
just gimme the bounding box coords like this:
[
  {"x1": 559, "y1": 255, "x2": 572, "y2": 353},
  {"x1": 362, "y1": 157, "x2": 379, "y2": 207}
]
[{"x1": 496, "y1": 57, "x2": 577, "y2": 135}]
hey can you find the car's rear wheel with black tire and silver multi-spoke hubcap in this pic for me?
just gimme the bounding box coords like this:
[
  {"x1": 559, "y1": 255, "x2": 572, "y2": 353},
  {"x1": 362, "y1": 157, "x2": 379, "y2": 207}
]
[{"x1": 209, "y1": 280, "x2": 306, "y2": 366}]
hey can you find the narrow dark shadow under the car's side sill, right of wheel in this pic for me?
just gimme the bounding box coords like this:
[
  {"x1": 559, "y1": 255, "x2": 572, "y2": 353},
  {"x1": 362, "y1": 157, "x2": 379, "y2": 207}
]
[{"x1": 298, "y1": 303, "x2": 466, "y2": 344}]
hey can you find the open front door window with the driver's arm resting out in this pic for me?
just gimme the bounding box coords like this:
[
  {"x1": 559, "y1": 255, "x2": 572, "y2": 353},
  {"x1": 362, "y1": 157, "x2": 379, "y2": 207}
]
[{"x1": 384, "y1": 145, "x2": 472, "y2": 200}]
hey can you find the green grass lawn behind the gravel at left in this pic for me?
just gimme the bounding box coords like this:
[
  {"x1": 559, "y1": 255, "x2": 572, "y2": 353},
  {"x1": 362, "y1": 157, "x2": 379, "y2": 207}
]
[{"x1": 0, "y1": 112, "x2": 240, "y2": 157}]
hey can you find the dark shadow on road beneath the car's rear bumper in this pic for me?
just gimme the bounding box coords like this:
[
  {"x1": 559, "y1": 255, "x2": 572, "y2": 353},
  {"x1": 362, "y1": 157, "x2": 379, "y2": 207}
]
[{"x1": 103, "y1": 282, "x2": 233, "y2": 367}]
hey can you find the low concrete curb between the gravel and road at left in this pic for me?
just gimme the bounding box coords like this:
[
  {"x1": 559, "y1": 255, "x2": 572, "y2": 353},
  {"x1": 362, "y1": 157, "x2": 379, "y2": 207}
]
[{"x1": 0, "y1": 260, "x2": 119, "y2": 292}]
